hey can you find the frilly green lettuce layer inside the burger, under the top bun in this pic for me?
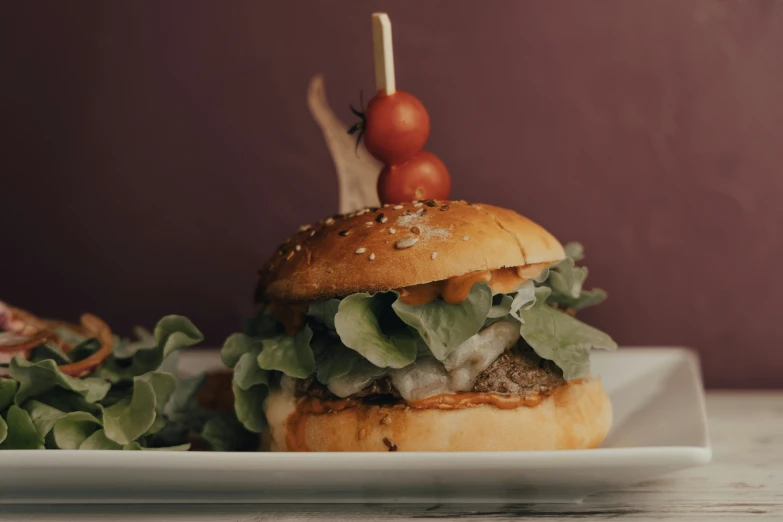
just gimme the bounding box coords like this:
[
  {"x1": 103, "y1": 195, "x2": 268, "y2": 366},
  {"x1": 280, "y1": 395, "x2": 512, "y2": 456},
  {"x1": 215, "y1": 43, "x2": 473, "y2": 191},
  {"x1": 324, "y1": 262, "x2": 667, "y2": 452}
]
[{"x1": 222, "y1": 243, "x2": 617, "y2": 432}]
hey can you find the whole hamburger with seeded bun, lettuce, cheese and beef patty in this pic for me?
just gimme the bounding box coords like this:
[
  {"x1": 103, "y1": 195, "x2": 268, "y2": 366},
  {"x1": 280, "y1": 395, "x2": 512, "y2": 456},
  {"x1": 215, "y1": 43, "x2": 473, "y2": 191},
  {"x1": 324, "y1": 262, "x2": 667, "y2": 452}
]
[{"x1": 223, "y1": 200, "x2": 616, "y2": 451}]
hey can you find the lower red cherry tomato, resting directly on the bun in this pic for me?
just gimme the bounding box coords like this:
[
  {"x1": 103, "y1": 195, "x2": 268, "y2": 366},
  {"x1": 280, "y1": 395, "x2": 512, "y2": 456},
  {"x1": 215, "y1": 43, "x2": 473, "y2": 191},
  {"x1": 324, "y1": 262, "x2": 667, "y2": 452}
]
[{"x1": 378, "y1": 150, "x2": 451, "y2": 203}]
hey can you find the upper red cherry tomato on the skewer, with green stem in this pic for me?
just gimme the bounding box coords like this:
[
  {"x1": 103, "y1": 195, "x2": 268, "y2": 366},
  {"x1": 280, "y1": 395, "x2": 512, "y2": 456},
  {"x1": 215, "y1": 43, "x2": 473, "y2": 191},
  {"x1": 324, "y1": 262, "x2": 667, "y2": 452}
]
[{"x1": 364, "y1": 91, "x2": 430, "y2": 165}]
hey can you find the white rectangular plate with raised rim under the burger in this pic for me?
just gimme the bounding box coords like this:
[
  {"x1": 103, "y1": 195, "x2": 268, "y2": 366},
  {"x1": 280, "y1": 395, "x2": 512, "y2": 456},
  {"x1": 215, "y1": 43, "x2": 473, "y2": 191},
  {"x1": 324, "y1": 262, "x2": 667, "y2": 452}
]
[{"x1": 0, "y1": 348, "x2": 712, "y2": 503}]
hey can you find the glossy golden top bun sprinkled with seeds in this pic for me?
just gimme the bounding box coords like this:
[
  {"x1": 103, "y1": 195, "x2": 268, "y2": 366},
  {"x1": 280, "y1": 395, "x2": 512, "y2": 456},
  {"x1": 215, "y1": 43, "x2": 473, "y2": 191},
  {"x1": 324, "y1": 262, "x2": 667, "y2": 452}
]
[{"x1": 256, "y1": 200, "x2": 565, "y2": 302}]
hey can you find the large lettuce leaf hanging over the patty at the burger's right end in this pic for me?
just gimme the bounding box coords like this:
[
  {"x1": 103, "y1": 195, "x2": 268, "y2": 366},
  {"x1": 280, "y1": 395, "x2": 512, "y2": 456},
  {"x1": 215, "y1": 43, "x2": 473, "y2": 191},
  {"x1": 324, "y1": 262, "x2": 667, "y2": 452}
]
[{"x1": 519, "y1": 287, "x2": 617, "y2": 380}]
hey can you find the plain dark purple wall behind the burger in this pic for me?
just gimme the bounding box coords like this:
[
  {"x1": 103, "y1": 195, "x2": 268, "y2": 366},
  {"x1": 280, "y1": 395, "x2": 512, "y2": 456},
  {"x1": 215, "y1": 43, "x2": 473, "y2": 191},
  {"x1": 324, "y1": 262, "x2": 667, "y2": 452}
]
[{"x1": 0, "y1": 0, "x2": 783, "y2": 387}]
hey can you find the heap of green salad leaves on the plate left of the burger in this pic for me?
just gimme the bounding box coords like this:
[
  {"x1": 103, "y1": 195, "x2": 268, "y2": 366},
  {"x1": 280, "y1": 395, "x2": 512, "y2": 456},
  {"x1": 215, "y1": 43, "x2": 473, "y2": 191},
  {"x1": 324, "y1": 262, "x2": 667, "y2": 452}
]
[{"x1": 0, "y1": 315, "x2": 251, "y2": 450}]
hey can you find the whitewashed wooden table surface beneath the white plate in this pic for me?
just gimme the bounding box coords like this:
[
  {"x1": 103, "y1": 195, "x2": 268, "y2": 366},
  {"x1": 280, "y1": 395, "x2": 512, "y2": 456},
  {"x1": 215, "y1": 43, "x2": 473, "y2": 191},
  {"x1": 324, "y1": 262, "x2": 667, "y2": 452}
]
[{"x1": 0, "y1": 391, "x2": 783, "y2": 522}]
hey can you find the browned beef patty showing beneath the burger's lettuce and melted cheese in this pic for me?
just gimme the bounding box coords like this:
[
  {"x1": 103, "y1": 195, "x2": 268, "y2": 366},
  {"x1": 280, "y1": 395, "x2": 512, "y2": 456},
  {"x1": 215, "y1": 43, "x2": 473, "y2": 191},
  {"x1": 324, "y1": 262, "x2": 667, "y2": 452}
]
[{"x1": 296, "y1": 345, "x2": 565, "y2": 401}]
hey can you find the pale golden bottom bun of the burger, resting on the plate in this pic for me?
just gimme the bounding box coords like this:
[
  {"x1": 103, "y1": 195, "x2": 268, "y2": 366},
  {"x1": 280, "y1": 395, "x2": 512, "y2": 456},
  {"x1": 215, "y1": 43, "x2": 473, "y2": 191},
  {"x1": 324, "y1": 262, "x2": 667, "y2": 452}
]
[{"x1": 265, "y1": 379, "x2": 612, "y2": 451}]
